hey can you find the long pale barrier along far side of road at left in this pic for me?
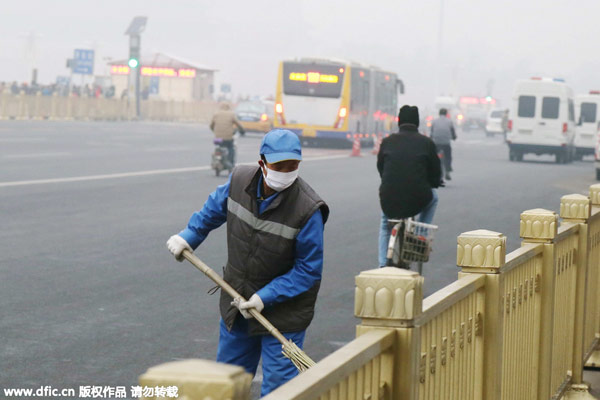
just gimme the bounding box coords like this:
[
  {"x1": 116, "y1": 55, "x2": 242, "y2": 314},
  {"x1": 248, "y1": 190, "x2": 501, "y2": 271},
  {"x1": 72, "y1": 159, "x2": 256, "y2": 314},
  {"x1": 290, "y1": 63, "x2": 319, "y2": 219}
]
[{"x1": 0, "y1": 93, "x2": 217, "y2": 122}]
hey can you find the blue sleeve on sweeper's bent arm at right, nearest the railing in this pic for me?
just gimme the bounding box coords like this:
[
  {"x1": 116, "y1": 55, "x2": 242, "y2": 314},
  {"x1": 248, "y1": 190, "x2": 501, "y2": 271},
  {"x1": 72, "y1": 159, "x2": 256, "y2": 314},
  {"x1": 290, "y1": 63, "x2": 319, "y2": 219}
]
[{"x1": 256, "y1": 210, "x2": 323, "y2": 307}]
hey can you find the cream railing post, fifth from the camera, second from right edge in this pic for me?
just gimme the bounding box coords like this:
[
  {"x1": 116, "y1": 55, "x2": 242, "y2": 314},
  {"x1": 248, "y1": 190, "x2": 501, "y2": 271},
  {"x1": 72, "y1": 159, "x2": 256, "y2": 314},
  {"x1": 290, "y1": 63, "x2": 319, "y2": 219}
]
[{"x1": 560, "y1": 194, "x2": 594, "y2": 399}]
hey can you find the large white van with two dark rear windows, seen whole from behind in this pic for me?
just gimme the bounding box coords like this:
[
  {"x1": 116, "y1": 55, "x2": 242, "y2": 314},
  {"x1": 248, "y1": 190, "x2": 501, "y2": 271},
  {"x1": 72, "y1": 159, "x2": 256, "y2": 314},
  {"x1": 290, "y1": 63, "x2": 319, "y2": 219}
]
[{"x1": 506, "y1": 78, "x2": 575, "y2": 163}]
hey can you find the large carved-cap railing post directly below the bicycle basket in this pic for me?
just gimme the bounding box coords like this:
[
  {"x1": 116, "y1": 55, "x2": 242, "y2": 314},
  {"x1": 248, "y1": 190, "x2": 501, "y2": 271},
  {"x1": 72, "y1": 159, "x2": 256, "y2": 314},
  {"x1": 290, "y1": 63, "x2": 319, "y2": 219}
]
[{"x1": 354, "y1": 267, "x2": 423, "y2": 400}]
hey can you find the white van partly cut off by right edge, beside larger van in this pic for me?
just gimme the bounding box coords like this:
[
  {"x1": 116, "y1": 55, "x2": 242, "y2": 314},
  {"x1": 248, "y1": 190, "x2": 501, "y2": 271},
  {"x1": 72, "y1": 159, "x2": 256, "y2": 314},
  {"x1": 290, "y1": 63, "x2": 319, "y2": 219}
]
[{"x1": 575, "y1": 90, "x2": 600, "y2": 158}]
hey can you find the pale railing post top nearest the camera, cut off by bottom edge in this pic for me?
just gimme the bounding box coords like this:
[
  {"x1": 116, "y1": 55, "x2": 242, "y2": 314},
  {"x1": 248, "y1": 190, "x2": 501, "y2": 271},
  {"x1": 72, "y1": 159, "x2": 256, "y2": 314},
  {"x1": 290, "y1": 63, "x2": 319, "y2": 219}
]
[{"x1": 138, "y1": 359, "x2": 252, "y2": 400}]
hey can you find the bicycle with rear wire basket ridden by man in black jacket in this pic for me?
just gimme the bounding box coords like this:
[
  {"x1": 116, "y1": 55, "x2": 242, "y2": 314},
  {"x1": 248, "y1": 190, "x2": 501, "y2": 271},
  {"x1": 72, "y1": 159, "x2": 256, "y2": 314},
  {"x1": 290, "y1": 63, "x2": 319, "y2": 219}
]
[{"x1": 386, "y1": 218, "x2": 438, "y2": 275}]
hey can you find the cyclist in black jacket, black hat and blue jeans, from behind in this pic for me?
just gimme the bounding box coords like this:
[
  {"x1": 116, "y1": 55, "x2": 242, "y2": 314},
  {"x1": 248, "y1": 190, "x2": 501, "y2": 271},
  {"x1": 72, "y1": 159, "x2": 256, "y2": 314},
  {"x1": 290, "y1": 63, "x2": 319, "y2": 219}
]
[{"x1": 377, "y1": 106, "x2": 442, "y2": 266}]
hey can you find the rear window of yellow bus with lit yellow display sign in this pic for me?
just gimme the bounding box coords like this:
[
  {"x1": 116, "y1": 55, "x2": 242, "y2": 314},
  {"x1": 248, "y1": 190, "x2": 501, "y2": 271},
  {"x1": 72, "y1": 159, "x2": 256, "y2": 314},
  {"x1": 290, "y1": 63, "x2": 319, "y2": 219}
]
[{"x1": 283, "y1": 62, "x2": 344, "y2": 98}]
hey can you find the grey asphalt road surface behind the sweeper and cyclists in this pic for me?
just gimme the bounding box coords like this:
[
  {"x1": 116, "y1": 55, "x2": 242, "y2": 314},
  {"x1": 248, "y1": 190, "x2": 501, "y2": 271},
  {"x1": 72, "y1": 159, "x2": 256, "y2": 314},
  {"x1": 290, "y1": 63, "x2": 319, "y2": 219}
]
[{"x1": 0, "y1": 121, "x2": 594, "y2": 396}]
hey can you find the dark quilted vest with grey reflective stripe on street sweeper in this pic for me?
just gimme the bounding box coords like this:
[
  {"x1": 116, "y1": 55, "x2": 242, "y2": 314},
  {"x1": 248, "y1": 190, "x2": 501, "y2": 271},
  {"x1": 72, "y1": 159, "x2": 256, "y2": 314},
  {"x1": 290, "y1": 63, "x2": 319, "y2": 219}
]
[{"x1": 220, "y1": 166, "x2": 329, "y2": 335}]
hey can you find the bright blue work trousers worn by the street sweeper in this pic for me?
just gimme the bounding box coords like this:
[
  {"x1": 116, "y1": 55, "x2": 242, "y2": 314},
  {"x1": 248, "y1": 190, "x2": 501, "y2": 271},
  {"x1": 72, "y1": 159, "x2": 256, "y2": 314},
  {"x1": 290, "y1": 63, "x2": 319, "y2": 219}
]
[{"x1": 217, "y1": 315, "x2": 306, "y2": 397}]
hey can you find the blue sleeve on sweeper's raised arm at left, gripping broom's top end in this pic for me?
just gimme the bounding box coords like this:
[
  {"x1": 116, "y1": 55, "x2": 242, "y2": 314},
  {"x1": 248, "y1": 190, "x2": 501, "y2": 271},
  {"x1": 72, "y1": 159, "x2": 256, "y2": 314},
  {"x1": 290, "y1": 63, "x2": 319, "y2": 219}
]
[{"x1": 179, "y1": 175, "x2": 231, "y2": 249}]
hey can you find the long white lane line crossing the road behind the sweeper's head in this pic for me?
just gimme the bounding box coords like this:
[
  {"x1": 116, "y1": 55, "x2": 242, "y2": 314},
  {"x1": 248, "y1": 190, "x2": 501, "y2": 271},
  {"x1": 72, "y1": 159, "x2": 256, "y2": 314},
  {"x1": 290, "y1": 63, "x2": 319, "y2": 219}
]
[{"x1": 0, "y1": 155, "x2": 348, "y2": 188}]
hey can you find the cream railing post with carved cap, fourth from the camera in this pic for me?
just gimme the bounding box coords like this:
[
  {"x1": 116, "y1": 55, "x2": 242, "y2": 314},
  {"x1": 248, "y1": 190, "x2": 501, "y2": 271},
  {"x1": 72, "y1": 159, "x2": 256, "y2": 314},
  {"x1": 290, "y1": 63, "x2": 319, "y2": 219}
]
[{"x1": 520, "y1": 208, "x2": 558, "y2": 400}]
